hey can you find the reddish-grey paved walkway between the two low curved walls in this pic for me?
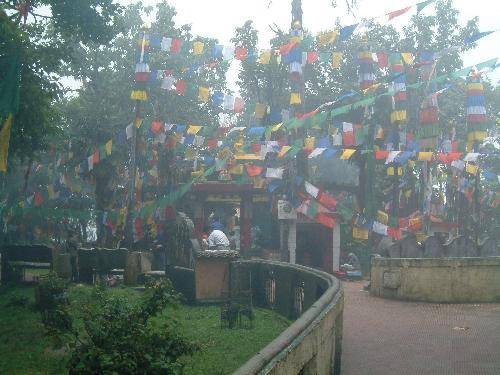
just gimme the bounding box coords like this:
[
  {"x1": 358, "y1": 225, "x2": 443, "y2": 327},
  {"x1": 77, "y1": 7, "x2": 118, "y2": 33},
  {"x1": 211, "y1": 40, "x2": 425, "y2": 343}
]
[{"x1": 342, "y1": 282, "x2": 500, "y2": 375}]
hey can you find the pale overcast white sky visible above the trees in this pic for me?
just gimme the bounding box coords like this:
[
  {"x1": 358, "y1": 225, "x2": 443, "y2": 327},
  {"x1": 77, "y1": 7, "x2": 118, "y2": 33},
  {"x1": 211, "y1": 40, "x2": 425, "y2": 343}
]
[{"x1": 119, "y1": 0, "x2": 500, "y2": 82}]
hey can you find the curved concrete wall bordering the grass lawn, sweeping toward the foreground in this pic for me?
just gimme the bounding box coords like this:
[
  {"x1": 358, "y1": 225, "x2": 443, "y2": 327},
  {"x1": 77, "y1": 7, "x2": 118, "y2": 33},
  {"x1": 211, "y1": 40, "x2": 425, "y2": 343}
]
[{"x1": 230, "y1": 260, "x2": 344, "y2": 375}]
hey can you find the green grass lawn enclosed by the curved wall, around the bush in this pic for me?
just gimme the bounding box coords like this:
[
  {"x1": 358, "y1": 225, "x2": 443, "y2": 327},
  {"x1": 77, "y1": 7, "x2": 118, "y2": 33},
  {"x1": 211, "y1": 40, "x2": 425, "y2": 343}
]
[{"x1": 0, "y1": 286, "x2": 290, "y2": 374}]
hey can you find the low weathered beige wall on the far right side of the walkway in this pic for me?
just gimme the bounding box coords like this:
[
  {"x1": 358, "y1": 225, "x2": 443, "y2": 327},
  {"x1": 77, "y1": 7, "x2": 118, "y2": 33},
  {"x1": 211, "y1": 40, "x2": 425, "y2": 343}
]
[{"x1": 370, "y1": 257, "x2": 500, "y2": 303}]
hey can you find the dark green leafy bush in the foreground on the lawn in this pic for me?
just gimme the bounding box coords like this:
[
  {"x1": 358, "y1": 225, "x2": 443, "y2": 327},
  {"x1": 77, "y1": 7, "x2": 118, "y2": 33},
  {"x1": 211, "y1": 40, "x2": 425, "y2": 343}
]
[{"x1": 68, "y1": 280, "x2": 197, "y2": 374}]
